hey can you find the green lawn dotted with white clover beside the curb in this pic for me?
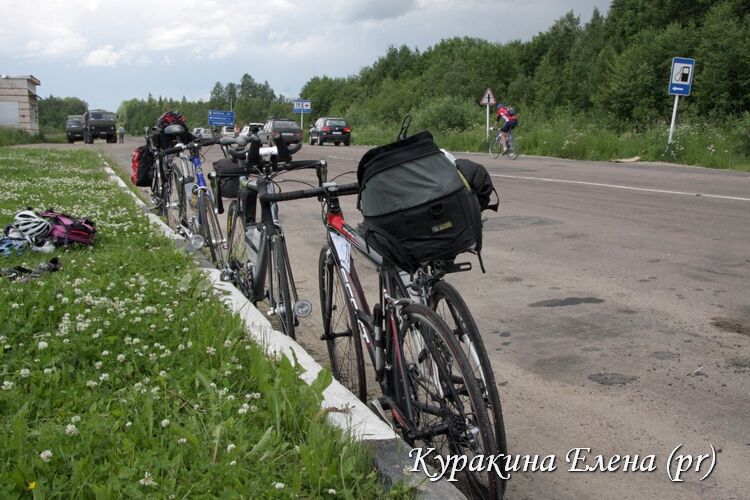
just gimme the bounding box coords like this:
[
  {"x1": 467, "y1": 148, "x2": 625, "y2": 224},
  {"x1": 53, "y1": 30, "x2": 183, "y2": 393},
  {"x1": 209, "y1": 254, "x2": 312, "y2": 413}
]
[{"x1": 0, "y1": 148, "x2": 396, "y2": 498}]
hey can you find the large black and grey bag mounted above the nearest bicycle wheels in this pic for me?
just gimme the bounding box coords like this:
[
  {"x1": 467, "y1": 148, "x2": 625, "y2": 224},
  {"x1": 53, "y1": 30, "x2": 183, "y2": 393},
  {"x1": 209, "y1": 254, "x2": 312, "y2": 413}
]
[{"x1": 357, "y1": 132, "x2": 482, "y2": 272}]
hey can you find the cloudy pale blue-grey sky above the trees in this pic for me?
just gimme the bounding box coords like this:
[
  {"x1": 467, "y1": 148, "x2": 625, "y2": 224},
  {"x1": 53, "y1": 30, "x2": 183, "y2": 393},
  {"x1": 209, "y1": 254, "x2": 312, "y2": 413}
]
[{"x1": 0, "y1": 0, "x2": 611, "y2": 111}]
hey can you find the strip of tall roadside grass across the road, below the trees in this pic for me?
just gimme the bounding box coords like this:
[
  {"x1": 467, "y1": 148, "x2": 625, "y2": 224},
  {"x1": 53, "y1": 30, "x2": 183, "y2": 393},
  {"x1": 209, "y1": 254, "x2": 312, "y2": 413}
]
[{"x1": 352, "y1": 113, "x2": 750, "y2": 171}]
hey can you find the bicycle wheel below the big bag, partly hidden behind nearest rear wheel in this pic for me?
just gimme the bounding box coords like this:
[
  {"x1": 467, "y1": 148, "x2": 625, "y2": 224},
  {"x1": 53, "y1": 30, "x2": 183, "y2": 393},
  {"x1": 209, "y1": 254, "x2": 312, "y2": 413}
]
[{"x1": 429, "y1": 281, "x2": 508, "y2": 492}]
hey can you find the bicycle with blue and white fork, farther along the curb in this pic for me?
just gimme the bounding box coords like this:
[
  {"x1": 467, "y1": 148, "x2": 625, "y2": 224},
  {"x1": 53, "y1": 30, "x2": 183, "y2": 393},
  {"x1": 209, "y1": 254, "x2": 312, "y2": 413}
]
[{"x1": 158, "y1": 133, "x2": 226, "y2": 269}]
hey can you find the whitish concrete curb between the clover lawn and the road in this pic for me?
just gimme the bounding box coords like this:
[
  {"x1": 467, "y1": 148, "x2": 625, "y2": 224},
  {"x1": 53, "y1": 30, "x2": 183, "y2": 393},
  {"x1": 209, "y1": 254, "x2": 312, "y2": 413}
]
[{"x1": 99, "y1": 155, "x2": 464, "y2": 499}]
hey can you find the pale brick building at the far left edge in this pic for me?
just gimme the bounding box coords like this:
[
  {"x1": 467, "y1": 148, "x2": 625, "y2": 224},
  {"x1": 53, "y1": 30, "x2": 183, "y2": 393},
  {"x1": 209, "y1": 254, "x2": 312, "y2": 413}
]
[{"x1": 0, "y1": 75, "x2": 41, "y2": 134}]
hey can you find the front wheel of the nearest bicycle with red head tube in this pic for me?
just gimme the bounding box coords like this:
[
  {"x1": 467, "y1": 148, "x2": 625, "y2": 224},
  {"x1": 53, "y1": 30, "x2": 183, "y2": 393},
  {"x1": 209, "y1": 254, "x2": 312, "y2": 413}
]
[{"x1": 318, "y1": 246, "x2": 367, "y2": 401}]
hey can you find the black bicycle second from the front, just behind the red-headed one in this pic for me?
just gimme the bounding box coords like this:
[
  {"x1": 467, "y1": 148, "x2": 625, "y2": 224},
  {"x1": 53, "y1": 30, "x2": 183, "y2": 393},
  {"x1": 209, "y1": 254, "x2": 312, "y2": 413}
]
[{"x1": 211, "y1": 139, "x2": 327, "y2": 338}]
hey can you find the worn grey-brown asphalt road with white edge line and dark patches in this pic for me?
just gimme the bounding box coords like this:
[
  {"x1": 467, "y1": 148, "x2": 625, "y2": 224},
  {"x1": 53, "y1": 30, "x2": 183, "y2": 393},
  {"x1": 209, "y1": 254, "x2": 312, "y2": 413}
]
[{"x1": 50, "y1": 139, "x2": 750, "y2": 498}]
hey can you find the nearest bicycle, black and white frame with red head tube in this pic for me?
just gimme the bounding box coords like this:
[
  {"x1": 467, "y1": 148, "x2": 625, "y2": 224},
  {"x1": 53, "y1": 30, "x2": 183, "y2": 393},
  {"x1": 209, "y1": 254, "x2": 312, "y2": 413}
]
[{"x1": 253, "y1": 182, "x2": 501, "y2": 498}]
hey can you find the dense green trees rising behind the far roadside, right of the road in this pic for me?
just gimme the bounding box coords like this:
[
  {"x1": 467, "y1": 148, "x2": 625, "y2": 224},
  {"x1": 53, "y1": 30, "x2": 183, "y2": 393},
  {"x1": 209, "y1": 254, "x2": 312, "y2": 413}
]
[{"x1": 301, "y1": 0, "x2": 750, "y2": 130}]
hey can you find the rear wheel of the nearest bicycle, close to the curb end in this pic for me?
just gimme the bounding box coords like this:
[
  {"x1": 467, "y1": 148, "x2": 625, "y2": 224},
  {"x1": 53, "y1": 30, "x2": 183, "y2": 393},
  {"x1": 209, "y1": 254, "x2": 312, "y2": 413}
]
[{"x1": 399, "y1": 304, "x2": 501, "y2": 498}]
